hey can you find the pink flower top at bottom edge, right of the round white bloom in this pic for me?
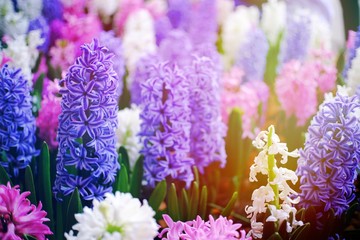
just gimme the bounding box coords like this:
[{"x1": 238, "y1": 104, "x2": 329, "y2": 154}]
[{"x1": 158, "y1": 214, "x2": 251, "y2": 240}]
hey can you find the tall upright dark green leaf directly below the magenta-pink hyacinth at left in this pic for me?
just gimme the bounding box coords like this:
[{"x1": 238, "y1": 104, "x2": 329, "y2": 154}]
[{"x1": 38, "y1": 142, "x2": 54, "y2": 232}]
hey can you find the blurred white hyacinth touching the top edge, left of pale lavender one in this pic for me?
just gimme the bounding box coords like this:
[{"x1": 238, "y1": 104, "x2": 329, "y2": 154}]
[{"x1": 261, "y1": 0, "x2": 286, "y2": 45}]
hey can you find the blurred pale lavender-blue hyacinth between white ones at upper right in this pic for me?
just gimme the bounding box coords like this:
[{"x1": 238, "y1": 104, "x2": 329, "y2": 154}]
[{"x1": 281, "y1": 15, "x2": 311, "y2": 63}]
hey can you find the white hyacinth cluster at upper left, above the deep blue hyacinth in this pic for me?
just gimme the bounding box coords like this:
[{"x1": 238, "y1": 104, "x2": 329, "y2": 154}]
[{"x1": 3, "y1": 30, "x2": 44, "y2": 85}]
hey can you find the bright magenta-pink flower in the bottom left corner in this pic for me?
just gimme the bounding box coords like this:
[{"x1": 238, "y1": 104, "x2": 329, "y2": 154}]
[{"x1": 0, "y1": 183, "x2": 52, "y2": 240}]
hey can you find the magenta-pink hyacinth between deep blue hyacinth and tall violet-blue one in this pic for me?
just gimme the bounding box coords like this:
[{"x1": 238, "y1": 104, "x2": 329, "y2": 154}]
[{"x1": 36, "y1": 79, "x2": 61, "y2": 149}]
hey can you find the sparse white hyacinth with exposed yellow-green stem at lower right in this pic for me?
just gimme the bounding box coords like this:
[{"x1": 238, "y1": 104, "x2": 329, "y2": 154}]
[{"x1": 245, "y1": 126, "x2": 302, "y2": 239}]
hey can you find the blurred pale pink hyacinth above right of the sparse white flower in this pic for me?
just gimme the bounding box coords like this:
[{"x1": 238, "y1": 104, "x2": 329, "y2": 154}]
[{"x1": 275, "y1": 60, "x2": 318, "y2": 126}]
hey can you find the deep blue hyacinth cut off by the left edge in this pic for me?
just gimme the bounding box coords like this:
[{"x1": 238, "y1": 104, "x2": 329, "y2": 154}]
[{"x1": 0, "y1": 65, "x2": 38, "y2": 177}]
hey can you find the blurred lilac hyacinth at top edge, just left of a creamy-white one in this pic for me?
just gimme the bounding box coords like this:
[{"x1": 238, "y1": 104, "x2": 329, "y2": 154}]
[{"x1": 188, "y1": 0, "x2": 217, "y2": 45}]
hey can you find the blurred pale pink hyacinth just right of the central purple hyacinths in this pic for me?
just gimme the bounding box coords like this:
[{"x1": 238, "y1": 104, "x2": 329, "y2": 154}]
[{"x1": 221, "y1": 68, "x2": 269, "y2": 138}]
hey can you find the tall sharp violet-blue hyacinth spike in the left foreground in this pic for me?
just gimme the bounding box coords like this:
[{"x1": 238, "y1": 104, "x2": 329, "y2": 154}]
[{"x1": 54, "y1": 39, "x2": 119, "y2": 200}]
